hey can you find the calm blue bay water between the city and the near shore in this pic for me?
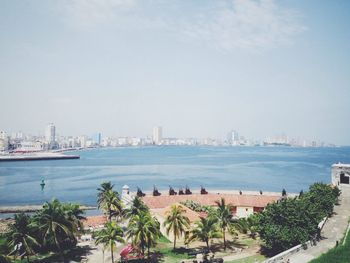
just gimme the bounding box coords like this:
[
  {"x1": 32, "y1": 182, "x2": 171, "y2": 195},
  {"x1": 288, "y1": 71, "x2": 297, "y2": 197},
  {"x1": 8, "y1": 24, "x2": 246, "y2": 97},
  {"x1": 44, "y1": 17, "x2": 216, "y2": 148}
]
[{"x1": 0, "y1": 146, "x2": 350, "y2": 206}]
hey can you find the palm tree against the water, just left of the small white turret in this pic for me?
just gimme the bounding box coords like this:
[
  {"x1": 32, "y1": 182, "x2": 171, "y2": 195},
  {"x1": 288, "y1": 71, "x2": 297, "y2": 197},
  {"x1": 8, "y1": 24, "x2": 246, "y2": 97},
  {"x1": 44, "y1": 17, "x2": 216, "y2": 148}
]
[{"x1": 97, "y1": 182, "x2": 123, "y2": 221}]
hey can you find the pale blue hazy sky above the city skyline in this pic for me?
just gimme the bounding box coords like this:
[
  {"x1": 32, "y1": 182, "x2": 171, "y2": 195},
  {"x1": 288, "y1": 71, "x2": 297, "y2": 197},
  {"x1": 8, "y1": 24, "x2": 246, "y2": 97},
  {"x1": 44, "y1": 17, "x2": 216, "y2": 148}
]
[{"x1": 0, "y1": 0, "x2": 350, "y2": 145}]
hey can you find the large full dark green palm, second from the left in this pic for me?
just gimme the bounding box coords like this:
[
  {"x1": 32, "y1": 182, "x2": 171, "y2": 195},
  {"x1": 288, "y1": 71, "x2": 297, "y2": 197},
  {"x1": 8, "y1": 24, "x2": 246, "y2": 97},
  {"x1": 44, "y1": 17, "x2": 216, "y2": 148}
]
[{"x1": 34, "y1": 199, "x2": 75, "y2": 258}]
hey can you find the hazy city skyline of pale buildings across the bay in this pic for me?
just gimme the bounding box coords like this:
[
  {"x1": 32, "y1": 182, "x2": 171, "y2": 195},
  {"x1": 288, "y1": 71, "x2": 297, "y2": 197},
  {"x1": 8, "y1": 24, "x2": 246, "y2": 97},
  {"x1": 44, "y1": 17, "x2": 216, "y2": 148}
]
[{"x1": 0, "y1": 123, "x2": 337, "y2": 151}]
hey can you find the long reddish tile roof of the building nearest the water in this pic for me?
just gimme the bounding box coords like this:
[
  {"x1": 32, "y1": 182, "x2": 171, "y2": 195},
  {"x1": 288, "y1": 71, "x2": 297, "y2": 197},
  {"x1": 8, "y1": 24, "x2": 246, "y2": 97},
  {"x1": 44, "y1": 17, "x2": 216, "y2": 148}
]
[{"x1": 142, "y1": 193, "x2": 280, "y2": 209}]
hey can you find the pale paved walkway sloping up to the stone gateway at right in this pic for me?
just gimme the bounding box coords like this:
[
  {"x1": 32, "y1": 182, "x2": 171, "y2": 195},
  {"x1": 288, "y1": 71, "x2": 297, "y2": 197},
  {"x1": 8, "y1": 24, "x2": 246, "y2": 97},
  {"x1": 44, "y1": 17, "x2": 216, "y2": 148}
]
[{"x1": 289, "y1": 185, "x2": 350, "y2": 263}]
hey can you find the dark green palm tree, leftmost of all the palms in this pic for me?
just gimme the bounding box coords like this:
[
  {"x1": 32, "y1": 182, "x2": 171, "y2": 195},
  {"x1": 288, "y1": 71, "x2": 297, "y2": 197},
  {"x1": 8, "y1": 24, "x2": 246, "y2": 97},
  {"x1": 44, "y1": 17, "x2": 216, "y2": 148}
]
[{"x1": 7, "y1": 213, "x2": 39, "y2": 262}]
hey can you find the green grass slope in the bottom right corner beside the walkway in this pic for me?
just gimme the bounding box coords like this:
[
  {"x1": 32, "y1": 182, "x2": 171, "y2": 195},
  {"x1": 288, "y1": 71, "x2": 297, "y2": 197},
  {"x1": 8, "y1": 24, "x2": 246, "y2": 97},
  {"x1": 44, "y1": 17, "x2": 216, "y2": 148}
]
[{"x1": 310, "y1": 227, "x2": 350, "y2": 263}]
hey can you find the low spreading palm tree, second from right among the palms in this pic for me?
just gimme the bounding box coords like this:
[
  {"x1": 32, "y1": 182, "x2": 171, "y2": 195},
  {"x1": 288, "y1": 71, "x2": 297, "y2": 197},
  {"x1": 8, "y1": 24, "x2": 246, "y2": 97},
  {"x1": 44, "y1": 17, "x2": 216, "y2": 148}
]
[{"x1": 188, "y1": 216, "x2": 221, "y2": 252}]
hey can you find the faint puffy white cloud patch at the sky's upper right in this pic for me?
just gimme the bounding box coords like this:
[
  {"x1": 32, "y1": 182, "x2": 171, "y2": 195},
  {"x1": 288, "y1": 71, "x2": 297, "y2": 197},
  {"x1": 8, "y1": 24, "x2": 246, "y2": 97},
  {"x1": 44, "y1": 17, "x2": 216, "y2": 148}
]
[{"x1": 179, "y1": 0, "x2": 306, "y2": 51}]
